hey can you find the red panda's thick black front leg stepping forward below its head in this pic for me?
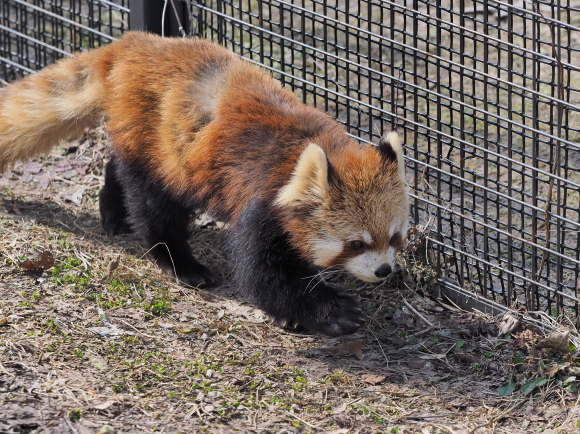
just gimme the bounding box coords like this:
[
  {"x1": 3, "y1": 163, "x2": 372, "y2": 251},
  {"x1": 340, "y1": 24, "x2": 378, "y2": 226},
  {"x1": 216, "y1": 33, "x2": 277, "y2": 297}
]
[{"x1": 228, "y1": 204, "x2": 364, "y2": 336}]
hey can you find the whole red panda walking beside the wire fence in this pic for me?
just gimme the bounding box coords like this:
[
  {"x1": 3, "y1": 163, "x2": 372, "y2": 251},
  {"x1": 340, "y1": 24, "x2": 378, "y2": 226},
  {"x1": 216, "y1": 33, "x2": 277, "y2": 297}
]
[{"x1": 0, "y1": 32, "x2": 409, "y2": 336}]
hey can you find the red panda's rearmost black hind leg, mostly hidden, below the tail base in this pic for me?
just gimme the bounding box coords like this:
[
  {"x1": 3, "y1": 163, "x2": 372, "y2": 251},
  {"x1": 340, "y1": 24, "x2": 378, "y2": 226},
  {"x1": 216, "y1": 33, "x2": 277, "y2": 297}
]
[{"x1": 99, "y1": 156, "x2": 132, "y2": 235}]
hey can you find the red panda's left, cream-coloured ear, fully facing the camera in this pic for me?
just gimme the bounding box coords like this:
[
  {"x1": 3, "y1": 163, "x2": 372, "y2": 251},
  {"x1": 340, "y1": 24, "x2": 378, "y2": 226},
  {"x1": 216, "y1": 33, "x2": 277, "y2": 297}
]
[{"x1": 276, "y1": 143, "x2": 330, "y2": 206}]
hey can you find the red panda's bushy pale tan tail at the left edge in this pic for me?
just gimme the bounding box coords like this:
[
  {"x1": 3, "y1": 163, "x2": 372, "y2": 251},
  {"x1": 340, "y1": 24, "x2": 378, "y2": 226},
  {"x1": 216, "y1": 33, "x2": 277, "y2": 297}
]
[{"x1": 0, "y1": 46, "x2": 112, "y2": 173}]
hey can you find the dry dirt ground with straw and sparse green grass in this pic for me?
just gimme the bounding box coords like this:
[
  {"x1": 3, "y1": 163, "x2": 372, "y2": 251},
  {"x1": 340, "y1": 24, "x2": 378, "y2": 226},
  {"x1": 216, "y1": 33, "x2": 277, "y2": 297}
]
[{"x1": 0, "y1": 129, "x2": 580, "y2": 434}]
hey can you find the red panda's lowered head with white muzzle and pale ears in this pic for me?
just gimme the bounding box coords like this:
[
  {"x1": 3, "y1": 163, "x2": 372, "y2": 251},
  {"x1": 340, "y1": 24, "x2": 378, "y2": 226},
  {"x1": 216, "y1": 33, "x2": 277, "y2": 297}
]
[{"x1": 276, "y1": 133, "x2": 409, "y2": 282}]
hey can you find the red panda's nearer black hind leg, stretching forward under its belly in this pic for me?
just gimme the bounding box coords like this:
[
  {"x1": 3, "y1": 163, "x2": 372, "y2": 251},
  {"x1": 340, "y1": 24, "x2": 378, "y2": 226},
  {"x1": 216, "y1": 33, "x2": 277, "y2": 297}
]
[{"x1": 116, "y1": 157, "x2": 216, "y2": 287}]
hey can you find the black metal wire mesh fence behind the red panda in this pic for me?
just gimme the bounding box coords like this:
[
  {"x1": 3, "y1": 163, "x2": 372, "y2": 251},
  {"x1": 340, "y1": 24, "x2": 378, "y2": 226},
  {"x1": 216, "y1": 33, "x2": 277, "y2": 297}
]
[{"x1": 0, "y1": 0, "x2": 580, "y2": 321}]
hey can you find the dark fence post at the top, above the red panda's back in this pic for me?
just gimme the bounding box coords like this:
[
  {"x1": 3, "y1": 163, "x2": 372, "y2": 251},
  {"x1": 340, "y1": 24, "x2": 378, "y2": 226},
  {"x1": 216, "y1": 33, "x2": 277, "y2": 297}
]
[{"x1": 129, "y1": 0, "x2": 189, "y2": 36}]
